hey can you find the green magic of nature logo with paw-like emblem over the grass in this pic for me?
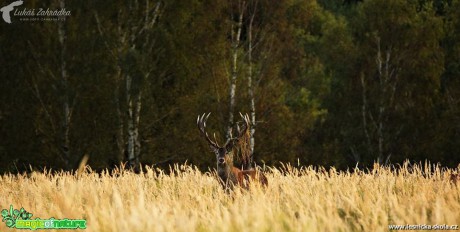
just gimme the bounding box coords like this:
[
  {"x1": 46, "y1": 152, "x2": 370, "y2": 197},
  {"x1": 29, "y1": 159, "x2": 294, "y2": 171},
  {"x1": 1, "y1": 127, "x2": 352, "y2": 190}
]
[{"x1": 2, "y1": 205, "x2": 86, "y2": 230}]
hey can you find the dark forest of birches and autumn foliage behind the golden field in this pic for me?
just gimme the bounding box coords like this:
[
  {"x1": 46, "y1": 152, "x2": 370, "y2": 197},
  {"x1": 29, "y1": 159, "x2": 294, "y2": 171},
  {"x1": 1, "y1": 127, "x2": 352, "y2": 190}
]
[{"x1": 0, "y1": 0, "x2": 460, "y2": 172}]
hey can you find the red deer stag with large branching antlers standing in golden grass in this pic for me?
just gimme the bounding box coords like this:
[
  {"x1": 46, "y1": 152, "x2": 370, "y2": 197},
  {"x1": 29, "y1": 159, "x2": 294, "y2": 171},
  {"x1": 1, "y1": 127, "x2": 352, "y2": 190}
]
[{"x1": 196, "y1": 113, "x2": 268, "y2": 190}]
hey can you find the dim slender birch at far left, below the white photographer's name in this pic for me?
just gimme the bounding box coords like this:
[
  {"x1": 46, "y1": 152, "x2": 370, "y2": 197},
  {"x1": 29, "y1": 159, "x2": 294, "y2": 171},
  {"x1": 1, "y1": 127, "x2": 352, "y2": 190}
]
[{"x1": 27, "y1": 0, "x2": 79, "y2": 170}]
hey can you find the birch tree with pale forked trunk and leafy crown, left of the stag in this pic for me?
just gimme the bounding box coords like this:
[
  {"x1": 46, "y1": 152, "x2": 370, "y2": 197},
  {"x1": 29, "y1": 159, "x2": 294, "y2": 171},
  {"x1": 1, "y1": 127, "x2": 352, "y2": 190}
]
[{"x1": 94, "y1": 0, "x2": 162, "y2": 171}]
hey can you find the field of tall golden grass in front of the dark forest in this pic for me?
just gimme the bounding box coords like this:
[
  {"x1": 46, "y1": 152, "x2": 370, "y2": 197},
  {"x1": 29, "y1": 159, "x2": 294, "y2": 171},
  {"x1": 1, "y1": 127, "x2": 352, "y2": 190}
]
[{"x1": 0, "y1": 164, "x2": 460, "y2": 232}]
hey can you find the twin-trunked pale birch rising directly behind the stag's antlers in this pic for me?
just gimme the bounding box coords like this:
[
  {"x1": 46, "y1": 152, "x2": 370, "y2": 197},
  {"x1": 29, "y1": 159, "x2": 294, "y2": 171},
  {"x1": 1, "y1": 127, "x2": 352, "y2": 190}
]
[{"x1": 226, "y1": 0, "x2": 271, "y2": 169}]
